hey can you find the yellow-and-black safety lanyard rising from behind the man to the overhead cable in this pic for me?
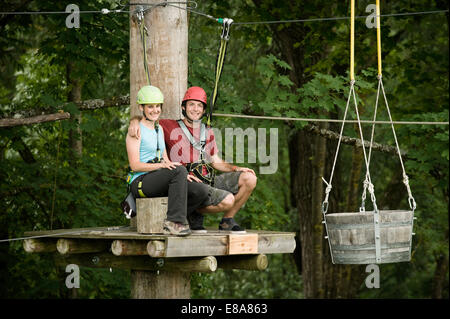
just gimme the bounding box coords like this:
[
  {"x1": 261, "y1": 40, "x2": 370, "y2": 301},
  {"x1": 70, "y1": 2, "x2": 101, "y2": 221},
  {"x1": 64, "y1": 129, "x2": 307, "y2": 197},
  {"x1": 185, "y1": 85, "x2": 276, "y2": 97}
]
[{"x1": 206, "y1": 18, "x2": 233, "y2": 127}]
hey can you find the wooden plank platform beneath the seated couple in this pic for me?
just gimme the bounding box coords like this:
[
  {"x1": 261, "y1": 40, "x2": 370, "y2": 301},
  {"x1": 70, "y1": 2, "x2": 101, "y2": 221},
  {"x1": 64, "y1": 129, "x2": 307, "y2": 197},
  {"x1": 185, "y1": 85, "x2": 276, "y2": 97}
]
[{"x1": 25, "y1": 226, "x2": 295, "y2": 258}]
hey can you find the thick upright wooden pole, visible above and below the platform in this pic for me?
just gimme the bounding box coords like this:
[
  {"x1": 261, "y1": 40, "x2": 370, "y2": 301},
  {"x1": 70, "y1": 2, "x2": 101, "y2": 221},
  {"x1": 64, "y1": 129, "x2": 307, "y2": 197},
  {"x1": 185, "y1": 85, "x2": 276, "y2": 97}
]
[{"x1": 130, "y1": 0, "x2": 190, "y2": 298}]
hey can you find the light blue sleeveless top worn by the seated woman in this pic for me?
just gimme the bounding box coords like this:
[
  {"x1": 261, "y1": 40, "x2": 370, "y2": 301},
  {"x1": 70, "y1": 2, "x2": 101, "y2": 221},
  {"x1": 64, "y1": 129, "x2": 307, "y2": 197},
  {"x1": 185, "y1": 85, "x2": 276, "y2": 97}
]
[{"x1": 129, "y1": 123, "x2": 166, "y2": 184}]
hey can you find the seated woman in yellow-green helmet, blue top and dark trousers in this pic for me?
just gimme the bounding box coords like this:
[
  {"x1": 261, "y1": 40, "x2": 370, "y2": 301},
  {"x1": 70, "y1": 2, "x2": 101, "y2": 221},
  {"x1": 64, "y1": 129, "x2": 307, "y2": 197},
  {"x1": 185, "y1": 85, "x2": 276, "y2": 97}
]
[{"x1": 126, "y1": 85, "x2": 208, "y2": 236}]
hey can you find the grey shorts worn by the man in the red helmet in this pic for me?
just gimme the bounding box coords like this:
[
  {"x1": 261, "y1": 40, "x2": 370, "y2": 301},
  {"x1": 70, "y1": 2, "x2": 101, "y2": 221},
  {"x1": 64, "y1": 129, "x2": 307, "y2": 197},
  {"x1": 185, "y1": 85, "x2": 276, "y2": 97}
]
[{"x1": 202, "y1": 172, "x2": 242, "y2": 207}]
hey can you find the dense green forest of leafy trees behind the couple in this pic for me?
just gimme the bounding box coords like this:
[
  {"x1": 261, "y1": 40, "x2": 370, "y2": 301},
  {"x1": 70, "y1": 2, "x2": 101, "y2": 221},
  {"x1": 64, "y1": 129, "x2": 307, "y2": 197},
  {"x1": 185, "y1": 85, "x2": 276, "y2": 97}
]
[{"x1": 0, "y1": 0, "x2": 449, "y2": 298}]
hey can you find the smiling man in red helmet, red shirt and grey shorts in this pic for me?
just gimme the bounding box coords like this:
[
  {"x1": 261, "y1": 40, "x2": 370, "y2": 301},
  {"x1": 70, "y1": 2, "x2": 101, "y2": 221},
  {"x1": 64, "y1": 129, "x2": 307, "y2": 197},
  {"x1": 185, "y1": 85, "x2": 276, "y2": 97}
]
[{"x1": 128, "y1": 86, "x2": 257, "y2": 233}]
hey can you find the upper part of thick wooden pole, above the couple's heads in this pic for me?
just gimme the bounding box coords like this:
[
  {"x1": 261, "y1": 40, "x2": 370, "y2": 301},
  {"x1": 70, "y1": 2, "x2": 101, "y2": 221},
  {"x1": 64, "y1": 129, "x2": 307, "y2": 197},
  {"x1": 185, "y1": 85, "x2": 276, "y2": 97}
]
[{"x1": 130, "y1": 0, "x2": 188, "y2": 119}]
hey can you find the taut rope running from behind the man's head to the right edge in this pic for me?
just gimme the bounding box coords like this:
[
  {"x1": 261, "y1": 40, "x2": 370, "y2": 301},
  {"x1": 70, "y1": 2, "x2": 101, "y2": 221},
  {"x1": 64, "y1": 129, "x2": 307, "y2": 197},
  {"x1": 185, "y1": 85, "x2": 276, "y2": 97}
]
[{"x1": 213, "y1": 113, "x2": 449, "y2": 125}]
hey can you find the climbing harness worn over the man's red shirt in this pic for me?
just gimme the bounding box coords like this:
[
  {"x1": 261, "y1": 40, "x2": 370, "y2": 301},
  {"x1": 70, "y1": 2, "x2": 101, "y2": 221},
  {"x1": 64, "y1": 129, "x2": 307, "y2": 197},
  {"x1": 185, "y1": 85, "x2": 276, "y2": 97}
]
[{"x1": 177, "y1": 120, "x2": 216, "y2": 186}]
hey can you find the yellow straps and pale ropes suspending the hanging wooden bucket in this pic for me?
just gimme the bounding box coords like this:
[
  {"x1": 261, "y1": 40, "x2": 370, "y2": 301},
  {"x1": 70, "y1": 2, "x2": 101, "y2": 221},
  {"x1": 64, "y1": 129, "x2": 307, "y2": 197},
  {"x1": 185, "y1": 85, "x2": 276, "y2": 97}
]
[{"x1": 322, "y1": 0, "x2": 416, "y2": 264}]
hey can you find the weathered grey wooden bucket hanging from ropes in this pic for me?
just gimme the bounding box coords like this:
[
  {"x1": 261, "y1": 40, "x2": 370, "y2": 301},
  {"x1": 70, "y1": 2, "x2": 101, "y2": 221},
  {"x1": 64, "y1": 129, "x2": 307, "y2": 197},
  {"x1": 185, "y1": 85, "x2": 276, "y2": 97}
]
[{"x1": 325, "y1": 210, "x2": 414, "y2": 264}]
